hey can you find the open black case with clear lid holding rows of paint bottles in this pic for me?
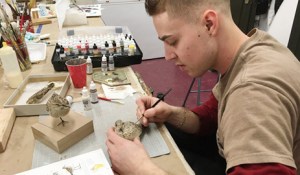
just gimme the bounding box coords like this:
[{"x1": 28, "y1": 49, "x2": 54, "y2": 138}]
[{"x1": 51, "y1": 26, "x2": 143, "y2": 71}]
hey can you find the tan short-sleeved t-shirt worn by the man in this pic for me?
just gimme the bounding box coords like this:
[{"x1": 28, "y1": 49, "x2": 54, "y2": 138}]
[{"x1": 213, "y1": 29, "x2": 300, "y2": 175}]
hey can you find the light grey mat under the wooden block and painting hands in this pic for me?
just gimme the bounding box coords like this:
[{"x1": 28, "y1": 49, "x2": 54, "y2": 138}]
[{"x1": 32, "y1": 94, "x2": 170, "y2": 168}]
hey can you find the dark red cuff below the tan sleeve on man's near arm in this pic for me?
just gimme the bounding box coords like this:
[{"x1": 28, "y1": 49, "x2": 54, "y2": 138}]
[{"x1": 228, "y1": 163, "x2": 297, "y2": 175}]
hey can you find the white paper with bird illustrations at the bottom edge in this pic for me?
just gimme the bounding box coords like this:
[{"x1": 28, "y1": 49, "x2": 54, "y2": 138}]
[{"x1": 18, "y1": 149, "x2": 114, "y2": 175}]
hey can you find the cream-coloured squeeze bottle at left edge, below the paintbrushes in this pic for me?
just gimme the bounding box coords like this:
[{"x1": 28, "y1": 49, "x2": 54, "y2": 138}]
[{"x1": 0, "y1": 42, "x2": 23, "y2": 88}]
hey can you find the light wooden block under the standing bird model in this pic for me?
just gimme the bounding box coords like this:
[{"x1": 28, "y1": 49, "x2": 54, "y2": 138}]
[{"x1": 31, "y1": 111, "x2": 94, "y2": 153}]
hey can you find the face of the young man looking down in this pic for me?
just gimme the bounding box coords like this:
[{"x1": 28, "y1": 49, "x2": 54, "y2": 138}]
[{"x1": 153, "y1": 12, "x2": 216, "y2": 77}]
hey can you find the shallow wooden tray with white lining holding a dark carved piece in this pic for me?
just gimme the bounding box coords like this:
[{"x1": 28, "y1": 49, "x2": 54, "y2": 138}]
[{"x1": 3, "y1": 74, "x2": 71, "y2": 116}]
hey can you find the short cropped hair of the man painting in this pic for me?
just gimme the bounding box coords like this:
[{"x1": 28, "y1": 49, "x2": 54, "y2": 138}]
[{"x1": 145, "y1": 0, "x2": 230, "y2": 21}]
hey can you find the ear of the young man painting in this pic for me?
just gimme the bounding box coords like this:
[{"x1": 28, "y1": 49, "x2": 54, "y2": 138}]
[{"x1": 203, "y1": 10, "x2": 218, "y2": 36}]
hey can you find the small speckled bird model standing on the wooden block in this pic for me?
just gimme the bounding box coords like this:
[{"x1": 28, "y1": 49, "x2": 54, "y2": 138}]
[{"x1": 46, "y1": 93, "x2": 70, "y2": 126}]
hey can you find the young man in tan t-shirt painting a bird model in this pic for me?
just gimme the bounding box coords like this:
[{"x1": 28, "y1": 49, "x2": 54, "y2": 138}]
[{"x1": 107, "y1": 0, "x2": 300, "y2": 175}]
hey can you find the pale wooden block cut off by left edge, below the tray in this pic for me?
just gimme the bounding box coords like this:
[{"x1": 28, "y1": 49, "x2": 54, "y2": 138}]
[{"x1": 0, "y1": 108, "x2": 16, "y2": 153}]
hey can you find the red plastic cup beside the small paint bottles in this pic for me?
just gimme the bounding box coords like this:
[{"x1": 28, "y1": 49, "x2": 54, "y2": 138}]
[{"x1": 66, "y1": 59, "x2": 86, "y2": 88}]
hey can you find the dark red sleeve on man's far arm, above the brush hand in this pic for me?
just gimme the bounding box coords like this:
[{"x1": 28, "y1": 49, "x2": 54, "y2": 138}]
[{"x1": 192, "y1": 93, "x2": 218, "y2": 136}]
